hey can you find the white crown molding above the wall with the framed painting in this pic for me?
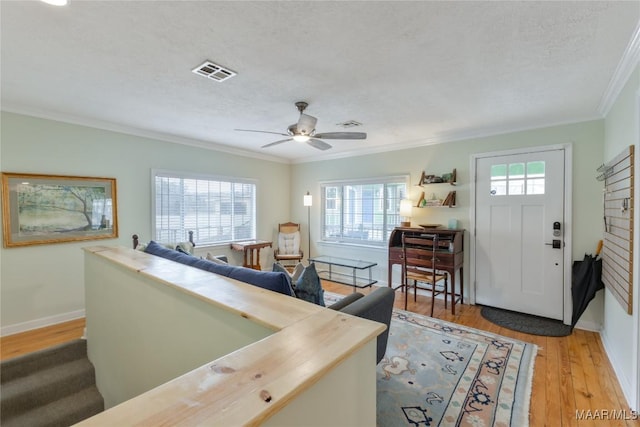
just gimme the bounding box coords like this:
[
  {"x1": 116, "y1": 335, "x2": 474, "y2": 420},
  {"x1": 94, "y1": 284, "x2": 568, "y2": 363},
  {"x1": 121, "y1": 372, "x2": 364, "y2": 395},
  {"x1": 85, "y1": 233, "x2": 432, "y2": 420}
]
[{"x1": 1, "y1": 103, "x2": 290, "y2": 164}]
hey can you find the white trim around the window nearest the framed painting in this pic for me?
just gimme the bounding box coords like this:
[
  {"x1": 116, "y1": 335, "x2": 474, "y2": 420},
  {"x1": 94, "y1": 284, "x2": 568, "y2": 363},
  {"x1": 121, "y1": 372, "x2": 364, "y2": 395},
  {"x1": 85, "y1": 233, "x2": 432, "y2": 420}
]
[{"x1": 149, "y1": 168, "x2": 259, "y2": 248}]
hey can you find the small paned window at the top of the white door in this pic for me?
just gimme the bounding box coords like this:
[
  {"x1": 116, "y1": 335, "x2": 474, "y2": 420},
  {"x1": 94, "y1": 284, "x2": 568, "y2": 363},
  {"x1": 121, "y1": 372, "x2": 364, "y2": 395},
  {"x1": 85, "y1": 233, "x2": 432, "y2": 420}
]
[{"x1": 491, "y1": 160, "x2": 545, "y2": 196}]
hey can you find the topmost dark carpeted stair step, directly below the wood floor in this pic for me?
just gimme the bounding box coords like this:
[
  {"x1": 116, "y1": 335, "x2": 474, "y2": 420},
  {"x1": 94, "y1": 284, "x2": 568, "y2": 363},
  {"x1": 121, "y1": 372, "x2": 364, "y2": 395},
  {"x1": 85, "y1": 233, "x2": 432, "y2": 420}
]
[{"x1": 0, "y1": 339, "x2": 87, "y2": 384}]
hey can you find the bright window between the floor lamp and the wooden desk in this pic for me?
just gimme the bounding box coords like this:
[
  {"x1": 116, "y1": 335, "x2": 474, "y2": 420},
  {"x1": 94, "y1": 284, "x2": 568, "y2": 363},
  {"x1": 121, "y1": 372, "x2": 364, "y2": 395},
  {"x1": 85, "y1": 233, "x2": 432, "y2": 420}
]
[{"x1": 321, "y1": 177, "x2": 407, "y2": 246}]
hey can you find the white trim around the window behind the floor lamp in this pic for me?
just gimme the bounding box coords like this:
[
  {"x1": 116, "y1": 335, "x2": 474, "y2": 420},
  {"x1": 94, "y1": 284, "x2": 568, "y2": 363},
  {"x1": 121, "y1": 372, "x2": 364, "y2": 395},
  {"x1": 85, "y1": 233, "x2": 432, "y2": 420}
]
[{"x1": 318, "y1": 173, "x2": 411, "y2": 248}]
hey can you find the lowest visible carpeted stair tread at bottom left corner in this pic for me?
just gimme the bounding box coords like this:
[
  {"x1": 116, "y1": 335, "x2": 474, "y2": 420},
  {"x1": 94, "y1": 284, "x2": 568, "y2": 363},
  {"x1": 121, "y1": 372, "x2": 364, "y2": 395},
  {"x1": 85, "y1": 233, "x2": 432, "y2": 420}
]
[{"x1": 2, "y1": 386, "x2": 104, "y2": 427}]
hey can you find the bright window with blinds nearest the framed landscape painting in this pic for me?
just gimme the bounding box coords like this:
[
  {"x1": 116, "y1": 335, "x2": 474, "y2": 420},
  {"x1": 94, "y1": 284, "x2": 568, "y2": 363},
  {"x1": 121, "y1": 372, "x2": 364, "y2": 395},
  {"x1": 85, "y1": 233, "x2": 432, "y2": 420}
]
[{"x1": 153, "y1": 171, "x2": 256, "y2": 246}]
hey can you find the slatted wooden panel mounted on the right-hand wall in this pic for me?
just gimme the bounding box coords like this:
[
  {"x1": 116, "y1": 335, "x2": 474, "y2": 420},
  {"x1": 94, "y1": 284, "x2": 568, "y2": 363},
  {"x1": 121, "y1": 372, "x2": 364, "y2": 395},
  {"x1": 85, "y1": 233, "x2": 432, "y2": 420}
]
[{"x1": 598, "y1": 145, "x2": 634, "y2": 314}]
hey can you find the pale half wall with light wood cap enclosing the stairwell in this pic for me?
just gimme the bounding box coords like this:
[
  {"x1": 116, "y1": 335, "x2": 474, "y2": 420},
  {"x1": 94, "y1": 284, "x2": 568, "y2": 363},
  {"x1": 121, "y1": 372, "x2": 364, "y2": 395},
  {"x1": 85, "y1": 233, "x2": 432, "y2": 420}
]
[{"x1": 78, "y1": 246, "x2": 385, "y2": 427}]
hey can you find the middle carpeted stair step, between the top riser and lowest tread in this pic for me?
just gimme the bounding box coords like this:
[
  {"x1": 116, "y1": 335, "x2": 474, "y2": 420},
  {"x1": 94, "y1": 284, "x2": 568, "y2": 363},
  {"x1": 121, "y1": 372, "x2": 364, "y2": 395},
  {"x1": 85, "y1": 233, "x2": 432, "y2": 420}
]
[{"x1": 0, "y1": 358, "x2": 95, "y2": 426}]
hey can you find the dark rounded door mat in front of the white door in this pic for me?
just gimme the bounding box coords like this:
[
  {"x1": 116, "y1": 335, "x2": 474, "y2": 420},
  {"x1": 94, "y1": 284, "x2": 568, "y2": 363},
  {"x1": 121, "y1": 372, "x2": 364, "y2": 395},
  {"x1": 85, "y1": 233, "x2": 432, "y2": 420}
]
[{"x1": 480, "y1": 306, "x2": 572, "y2": 337}]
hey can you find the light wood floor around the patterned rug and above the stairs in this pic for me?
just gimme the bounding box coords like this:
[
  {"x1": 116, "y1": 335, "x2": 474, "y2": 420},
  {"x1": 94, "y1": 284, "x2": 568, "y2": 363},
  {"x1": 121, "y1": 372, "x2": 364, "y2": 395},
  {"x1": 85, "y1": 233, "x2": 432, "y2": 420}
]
[{"x1": 0, "y1": 282, "x2": 640, "y2": 427}]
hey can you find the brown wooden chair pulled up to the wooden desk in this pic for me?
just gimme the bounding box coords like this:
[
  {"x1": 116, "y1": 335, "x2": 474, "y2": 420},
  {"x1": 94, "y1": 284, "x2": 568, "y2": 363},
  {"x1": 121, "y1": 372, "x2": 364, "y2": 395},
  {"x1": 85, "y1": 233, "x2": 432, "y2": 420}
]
[{"x1": 401, "y1": 234, "x2": 448, "y2": 317}]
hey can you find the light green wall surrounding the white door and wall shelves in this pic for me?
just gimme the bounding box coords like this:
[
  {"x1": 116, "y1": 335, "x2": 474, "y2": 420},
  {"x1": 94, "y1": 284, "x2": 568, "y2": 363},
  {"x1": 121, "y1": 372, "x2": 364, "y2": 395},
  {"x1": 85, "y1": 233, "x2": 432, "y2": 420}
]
[{"x1": 291, "y1": 120, "x2": 604, "y2": 328}]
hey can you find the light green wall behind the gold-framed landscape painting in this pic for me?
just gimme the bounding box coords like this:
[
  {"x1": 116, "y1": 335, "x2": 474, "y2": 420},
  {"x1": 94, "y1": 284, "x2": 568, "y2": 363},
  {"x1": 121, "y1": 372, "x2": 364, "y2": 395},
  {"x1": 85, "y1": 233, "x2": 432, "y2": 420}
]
[{"x1": 0, "y1": 112, "x2": 290, "y2": 334}]
